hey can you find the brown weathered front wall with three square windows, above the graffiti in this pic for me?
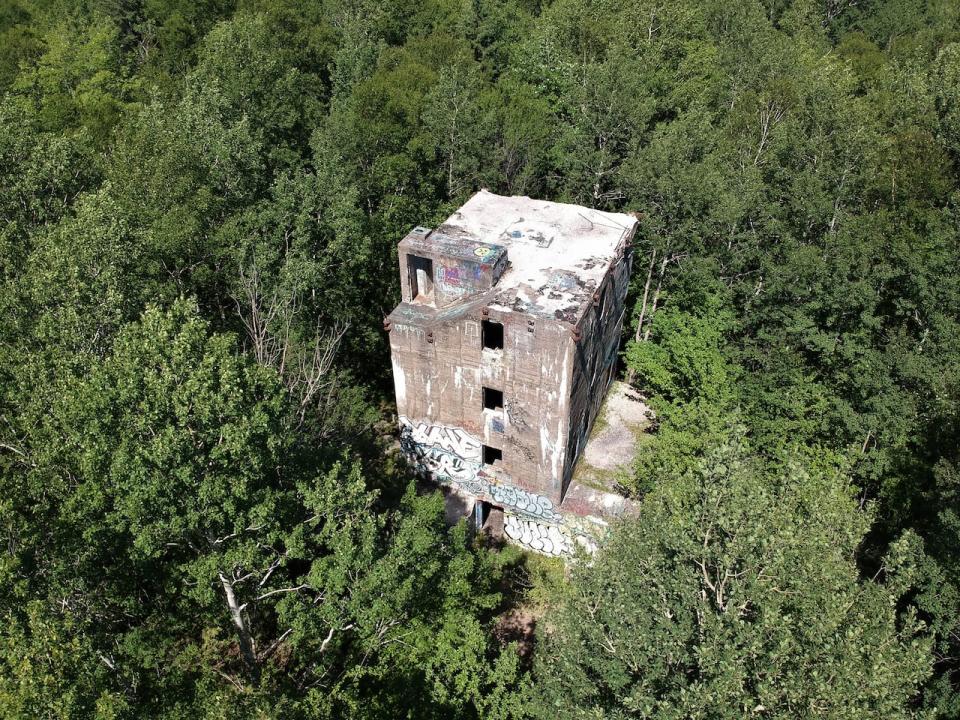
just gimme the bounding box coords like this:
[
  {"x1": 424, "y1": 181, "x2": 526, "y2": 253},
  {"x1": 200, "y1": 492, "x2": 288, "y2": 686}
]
[{"x1": 390, "y1": 308, "x2": 574, "y2": 504}]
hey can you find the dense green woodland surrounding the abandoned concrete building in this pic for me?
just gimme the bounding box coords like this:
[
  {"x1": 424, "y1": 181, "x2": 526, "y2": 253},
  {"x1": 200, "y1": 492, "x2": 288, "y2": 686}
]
[{"x1": 0, "y1": 0, "x2": 960, "y2": 720}]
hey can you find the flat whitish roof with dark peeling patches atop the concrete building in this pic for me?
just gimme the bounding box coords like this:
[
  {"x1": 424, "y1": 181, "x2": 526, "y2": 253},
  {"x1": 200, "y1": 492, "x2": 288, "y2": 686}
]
[{"x1": 436, "y1": 190, "x2": 637, "y2": 322}]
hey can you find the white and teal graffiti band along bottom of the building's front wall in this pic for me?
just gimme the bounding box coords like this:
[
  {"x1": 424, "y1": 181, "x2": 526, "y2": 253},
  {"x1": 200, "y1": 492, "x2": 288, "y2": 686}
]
[{"x1": 400, "y1": 415, "x2": 563, "y2": 523}]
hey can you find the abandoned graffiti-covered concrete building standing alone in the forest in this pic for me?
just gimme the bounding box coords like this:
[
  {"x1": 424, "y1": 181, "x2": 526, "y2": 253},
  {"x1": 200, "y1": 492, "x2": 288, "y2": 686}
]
[{"x1": 384, "y1": 190, "x2": 637, "y2": 555}]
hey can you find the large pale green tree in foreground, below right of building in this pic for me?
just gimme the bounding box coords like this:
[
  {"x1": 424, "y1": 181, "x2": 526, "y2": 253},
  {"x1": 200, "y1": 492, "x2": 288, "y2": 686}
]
[{"x1": 536, "y1": 441, "x2": 930, "y2": 718}]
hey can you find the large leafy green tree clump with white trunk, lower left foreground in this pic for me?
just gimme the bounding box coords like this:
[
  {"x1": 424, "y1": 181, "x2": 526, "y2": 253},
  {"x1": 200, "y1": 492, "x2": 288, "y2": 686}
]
[{"x1": 3, "y1": 302, "x2": 516, "y2": 717}]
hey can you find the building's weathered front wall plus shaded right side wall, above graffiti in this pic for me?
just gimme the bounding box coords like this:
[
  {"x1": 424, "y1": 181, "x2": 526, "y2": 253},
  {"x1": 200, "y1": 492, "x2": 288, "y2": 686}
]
[{"x1": 390, "y1": 242, "x2": 630, "y2": 505}]
